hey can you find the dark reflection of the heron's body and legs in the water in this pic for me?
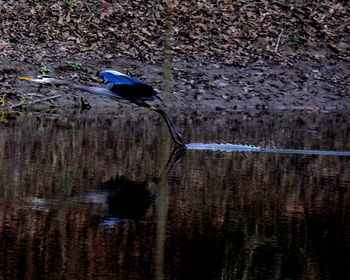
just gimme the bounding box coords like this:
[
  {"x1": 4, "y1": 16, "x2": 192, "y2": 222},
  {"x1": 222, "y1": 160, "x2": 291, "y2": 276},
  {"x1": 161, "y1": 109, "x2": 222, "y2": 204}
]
[{"x1": 77, "y1": 148, "x2": 186, "y2": 226}]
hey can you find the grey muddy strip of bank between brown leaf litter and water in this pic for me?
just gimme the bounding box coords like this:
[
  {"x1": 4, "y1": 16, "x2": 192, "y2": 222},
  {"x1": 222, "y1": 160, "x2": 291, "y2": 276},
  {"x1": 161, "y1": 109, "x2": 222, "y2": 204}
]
[{"x1": 0, "y1": 59, "x2": 350, "y2": 111}]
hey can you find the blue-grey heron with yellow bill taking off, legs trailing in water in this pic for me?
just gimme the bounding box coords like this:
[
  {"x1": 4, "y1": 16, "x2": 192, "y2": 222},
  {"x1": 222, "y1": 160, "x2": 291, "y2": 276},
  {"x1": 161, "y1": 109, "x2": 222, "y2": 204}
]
[{"x1": 19, "y1": 70, "x2": 186, "y2": 149}]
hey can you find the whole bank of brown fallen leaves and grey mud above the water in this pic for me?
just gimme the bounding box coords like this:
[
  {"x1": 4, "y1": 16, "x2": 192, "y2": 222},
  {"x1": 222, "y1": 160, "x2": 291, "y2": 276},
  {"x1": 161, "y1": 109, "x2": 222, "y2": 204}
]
[{"x1": 0, "y1": 0, "x2": 350, "y2": 111}]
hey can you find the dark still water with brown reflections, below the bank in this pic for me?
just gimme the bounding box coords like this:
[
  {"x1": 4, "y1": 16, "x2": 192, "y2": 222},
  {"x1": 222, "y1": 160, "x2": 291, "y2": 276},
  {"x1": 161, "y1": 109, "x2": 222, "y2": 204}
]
[{"x1": 0, "y1": 111, "x2": 350, "y2": 279}]
